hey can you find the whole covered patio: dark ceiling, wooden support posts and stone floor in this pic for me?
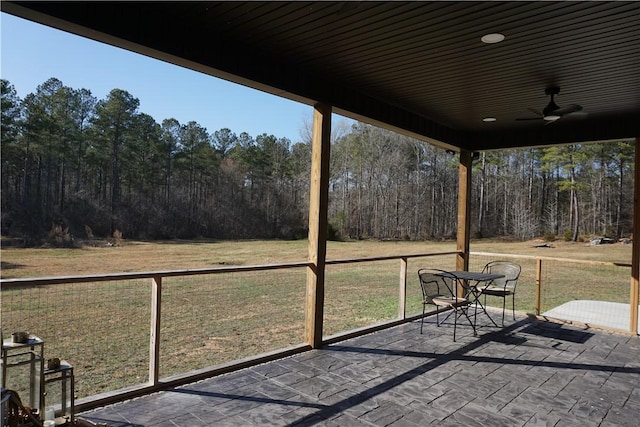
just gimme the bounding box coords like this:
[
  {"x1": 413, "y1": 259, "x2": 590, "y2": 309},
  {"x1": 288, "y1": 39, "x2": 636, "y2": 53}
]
[{"x1": 1, "y1": 1, "x2": 640, "y2": 427}]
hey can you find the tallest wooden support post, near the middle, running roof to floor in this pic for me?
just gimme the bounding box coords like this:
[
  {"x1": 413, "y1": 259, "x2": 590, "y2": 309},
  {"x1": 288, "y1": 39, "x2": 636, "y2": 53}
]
[{"x1": 305, "y1": 104, "x2": 331, "y2": 348}]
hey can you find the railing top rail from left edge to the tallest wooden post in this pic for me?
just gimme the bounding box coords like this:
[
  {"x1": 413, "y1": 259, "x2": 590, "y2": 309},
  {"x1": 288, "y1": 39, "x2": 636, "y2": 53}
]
[{"x1": 0, "y1": 262, "x2": 311, "y2": 288}]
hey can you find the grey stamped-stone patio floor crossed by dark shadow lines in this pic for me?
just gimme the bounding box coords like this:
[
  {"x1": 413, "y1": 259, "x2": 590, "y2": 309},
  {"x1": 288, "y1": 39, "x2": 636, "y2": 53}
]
[{"x1": 80, "y1": 316, "x2": 640, "y2": 427}]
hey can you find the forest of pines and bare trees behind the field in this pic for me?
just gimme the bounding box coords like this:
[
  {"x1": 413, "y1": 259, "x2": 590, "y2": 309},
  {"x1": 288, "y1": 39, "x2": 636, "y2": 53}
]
[{"x1": 1, "y1": 78, "x2": 634, "y2": 246}]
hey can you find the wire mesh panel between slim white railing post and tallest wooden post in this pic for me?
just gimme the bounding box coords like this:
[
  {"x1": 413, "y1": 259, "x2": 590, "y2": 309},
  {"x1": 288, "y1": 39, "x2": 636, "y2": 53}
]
[{"x1": 159, "y1": 268, "x2": 306, "y2": 377}]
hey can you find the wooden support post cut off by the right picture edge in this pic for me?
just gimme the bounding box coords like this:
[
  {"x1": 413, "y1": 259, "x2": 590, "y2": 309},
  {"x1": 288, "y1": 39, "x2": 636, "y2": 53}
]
[{"x1": 629, "y1": 137, "x2": 640, "y2": 334}]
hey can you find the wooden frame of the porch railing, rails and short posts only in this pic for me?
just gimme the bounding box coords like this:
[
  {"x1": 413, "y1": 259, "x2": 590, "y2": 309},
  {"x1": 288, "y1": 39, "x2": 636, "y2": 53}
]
[{"x1": 0, "y1": 250, "x2": 637, "y2": 411}]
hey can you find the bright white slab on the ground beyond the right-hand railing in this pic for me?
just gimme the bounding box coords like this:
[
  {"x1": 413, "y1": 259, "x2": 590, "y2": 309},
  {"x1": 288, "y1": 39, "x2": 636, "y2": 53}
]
[{"x1": 542, "y1": 300, "x2": 640, "y2": 331}]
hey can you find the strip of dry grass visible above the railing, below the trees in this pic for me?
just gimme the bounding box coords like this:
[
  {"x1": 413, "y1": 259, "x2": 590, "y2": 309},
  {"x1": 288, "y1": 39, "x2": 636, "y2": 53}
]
[{"x1": 1, "y1": 236, "x2": 631, "y2": 279}]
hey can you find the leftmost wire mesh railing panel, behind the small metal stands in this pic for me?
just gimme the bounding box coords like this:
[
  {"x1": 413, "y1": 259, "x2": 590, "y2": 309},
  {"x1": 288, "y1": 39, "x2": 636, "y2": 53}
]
[{"x1": 2, "y1": 279, "x2": 150, "y2": 397}]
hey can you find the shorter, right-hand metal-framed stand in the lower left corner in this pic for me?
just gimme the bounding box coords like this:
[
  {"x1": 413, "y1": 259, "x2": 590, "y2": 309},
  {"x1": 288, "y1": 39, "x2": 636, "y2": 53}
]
[{"x1": 43, "y1": 360, "x2": 75, "y2": 425}]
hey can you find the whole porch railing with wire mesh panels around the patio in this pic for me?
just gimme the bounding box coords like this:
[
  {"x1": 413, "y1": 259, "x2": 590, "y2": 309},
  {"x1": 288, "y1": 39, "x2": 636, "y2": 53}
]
[{"x1": 0, "y1": 251, "x2": 637, "y2": 411}]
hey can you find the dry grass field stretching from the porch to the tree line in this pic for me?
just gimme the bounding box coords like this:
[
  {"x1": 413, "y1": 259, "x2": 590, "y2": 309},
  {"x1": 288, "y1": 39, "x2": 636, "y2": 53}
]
[{"x1": 1, "y1": 241, "x2": 631, "y2": 397}]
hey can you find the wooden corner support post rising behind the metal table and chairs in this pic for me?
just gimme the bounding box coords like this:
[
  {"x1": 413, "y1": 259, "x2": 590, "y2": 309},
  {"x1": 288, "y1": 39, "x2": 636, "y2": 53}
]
[{"x1": 456, "y1": 150, "x2": 472, "y2": 270}]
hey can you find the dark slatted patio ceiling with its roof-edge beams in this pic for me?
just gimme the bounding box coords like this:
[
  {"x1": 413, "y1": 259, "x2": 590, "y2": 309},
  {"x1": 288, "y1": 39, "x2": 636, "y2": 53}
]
[{"x1": 1, "y1": 1, "x2": 640, "y2": 151}]
